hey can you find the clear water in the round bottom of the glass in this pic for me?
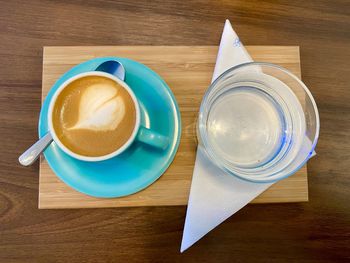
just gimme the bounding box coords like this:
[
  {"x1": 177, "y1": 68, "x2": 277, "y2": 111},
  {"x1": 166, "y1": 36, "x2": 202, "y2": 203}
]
[{"x1": 207, "y1": 87, "x2": 286, "y2": 168}]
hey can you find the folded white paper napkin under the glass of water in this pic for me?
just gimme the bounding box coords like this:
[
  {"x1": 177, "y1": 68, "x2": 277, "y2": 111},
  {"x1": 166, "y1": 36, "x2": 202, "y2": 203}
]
[{"x1": 181, "y1": 20, "x2": 272, "y2": 252}]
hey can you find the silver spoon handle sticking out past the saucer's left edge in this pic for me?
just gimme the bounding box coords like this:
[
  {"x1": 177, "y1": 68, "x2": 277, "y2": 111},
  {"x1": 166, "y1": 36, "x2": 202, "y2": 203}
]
[{"x1": 18, "y1": 132, "x2": 52, "y2": 166}]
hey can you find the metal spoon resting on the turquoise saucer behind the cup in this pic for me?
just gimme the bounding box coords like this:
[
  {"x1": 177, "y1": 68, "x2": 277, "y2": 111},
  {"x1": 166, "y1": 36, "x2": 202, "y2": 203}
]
[{"x1": 18, "y1": 60, "x2": 125, "y2": 166}]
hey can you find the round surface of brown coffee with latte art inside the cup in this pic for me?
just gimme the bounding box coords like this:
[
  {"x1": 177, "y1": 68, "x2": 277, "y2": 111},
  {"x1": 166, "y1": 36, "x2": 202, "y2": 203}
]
[{"x1": 52, "y1": 76, "x2": 136, "y2": 157}]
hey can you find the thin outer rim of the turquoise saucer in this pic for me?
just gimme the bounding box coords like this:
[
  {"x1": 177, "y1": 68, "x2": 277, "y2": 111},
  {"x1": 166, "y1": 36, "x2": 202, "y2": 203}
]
[{"x1": 38, "y1": 56, "x2": 182, "y2": 198}]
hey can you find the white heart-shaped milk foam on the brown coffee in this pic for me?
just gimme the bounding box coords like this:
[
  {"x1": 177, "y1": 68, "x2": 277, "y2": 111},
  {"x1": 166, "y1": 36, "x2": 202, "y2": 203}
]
[{"x1": 67, "y1": 83, "x2": 126, "y2": 131}]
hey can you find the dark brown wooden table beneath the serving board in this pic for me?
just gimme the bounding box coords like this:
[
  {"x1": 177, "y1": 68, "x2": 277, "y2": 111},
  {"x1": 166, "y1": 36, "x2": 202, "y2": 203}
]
[{"x1": 0, "y1": 1, "x2": 350, "y2": 262}]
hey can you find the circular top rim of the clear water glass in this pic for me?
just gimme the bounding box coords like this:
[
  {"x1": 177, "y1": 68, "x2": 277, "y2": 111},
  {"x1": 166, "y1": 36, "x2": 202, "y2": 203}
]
[{"x1": 198, "y1": 62, "x2": 320, "y2": 183}]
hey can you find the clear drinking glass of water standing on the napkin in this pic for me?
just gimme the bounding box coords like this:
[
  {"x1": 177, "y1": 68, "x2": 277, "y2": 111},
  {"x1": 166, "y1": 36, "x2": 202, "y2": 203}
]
[{"x1": 197, "y1": 62, "x2": 320, "y2": 183}]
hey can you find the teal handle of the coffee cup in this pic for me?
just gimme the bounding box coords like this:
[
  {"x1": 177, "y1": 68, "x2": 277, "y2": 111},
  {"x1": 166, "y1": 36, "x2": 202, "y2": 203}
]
[{"x1": 136, "y1": 126, "x2": 169, "y2": 150}]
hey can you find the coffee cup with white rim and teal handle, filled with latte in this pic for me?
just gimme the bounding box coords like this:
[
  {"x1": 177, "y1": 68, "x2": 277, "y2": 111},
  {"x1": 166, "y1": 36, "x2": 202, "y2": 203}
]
[{"x1": 48, "y1": 71, "x2": 169, "y2": 162}]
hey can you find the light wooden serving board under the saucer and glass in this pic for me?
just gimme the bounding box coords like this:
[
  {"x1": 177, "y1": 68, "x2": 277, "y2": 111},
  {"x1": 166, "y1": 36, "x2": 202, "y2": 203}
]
[{"x1": 39, "y1": 46, "x2": 308, "y2": 208}]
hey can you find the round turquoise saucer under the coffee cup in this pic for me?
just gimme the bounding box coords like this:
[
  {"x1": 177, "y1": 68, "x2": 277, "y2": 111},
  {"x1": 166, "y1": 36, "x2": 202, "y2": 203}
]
[{"x1": 39, "y1": 57, "x2": 181, "y2": 198}]
